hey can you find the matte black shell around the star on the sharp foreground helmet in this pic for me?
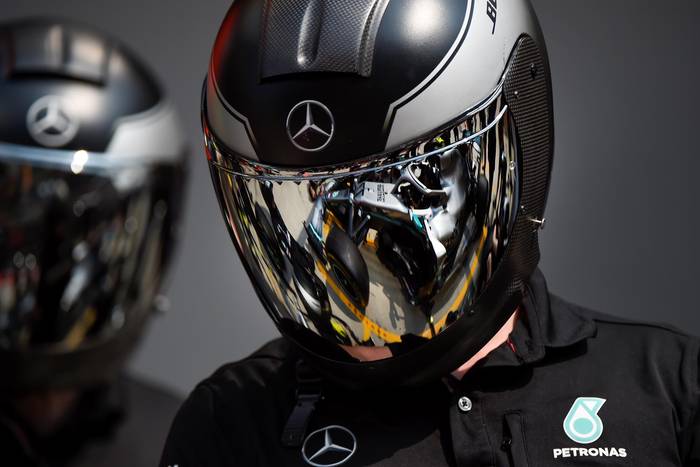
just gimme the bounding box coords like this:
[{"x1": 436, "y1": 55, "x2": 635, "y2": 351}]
[{"x1": 211, "y1": 0, "x2": 470, "y2": 166}]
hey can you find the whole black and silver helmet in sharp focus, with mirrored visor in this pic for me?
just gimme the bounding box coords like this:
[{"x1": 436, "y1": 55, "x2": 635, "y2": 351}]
[{"x1": 202, "y1": 0, "x2": 553, "y2": 384}]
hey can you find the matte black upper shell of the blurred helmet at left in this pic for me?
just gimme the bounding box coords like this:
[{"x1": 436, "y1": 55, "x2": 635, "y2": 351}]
[{"x1": 0, "y1": 19, "x2": 161, "y2": 152}]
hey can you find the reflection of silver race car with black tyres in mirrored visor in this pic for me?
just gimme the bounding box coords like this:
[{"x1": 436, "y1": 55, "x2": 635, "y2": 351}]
[{"x1": 305, "y1": 149, "x2": 488, "y2": 310}]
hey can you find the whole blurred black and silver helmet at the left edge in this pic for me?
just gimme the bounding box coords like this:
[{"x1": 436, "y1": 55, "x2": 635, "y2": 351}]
[{"x1": 0, "y1": 19, "x2": 185, "y2": 392}]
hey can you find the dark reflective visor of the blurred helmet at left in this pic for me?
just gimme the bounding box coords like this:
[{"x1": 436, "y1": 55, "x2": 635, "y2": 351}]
[{"x1": 0, "y1": 144, "x2": 181, "y2": 351}]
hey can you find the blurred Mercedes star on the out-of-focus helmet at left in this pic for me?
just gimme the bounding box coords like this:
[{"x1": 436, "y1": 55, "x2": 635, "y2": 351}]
[{"x1": 27, "y1": 96, "x2": 80, "y2": 148}]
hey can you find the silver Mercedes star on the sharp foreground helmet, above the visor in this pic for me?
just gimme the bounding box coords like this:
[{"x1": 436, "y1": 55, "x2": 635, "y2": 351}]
[{"x1": 287, "y1": 100, "x2": 335, "y2": 152}]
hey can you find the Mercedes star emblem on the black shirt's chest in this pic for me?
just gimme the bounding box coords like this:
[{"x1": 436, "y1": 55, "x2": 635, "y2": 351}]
[{"x1": 301, "y1": 425, "x2": 357, "y2": 467}]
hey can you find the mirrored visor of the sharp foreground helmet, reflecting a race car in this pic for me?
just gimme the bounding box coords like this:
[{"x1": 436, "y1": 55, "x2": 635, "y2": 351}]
[{"x1": 205, "y1": 91, "x2": 520, "y2": 356}]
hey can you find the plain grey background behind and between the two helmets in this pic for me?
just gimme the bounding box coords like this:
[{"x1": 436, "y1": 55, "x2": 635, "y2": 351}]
[{"x1": 0, "y1": 0, "x2": 700, "y2": 394}]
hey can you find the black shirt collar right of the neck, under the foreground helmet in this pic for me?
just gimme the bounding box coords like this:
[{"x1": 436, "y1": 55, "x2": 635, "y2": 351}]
[{"x1": 477, "y1": 269, "x2": 596, "y2": 368}]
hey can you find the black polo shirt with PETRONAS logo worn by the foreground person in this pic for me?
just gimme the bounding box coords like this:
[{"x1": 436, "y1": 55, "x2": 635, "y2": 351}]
[{"x1": 161, "y1": 272, "x2": 700, "y2": 467}]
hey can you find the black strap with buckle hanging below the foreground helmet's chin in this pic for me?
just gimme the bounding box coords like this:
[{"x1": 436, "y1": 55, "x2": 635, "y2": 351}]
[{"x1": 282, "y1": 360, "x2": 323, "y2": 448}]
